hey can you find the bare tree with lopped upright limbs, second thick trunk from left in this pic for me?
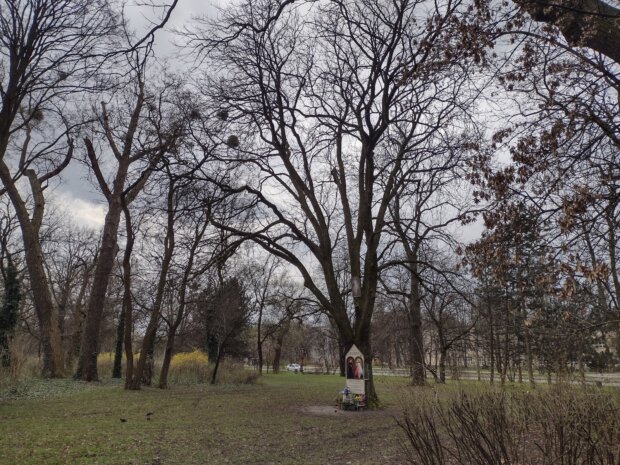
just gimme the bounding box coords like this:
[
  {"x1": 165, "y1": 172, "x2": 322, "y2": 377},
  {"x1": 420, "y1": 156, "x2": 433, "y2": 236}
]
[{"x1": 76, "y1": 45, "x2": 184, "y2": 381}]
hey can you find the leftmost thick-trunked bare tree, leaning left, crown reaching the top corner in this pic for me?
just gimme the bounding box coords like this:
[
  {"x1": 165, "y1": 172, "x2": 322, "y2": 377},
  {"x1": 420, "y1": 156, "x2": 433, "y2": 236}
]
[{"x1": 0, "y1": 0, "x2": 116, "y2": 377}]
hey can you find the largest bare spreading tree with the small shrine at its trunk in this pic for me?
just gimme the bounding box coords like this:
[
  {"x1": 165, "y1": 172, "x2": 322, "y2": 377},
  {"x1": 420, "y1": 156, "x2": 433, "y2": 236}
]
[{"x1": 190, "y1": 0, "x2": 476, "y2": 403}]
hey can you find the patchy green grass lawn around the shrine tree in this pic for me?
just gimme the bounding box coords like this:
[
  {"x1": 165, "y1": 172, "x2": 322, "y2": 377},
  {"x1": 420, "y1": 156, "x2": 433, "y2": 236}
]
[{"x1": 0, "y1": 373, "x2": 408, "y2": 465}]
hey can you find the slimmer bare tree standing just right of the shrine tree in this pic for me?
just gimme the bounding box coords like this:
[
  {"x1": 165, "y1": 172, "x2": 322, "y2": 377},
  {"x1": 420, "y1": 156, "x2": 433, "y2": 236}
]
[{"x1": 383, "y1": 138, "x2": 475, "y2": 384}]
